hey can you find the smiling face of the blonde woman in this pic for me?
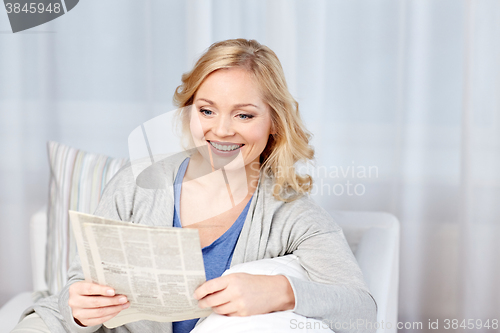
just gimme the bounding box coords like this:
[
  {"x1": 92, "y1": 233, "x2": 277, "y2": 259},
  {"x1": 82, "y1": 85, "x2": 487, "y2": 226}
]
[{"x1": 191, "y1": 68, "x2": 272, "y2": 168}]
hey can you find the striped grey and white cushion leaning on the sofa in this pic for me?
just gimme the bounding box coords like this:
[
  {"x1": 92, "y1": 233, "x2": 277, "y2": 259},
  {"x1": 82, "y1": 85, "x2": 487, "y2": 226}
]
[{"x1": 45, "y1": 142, "x2": 127, "y2": 294}]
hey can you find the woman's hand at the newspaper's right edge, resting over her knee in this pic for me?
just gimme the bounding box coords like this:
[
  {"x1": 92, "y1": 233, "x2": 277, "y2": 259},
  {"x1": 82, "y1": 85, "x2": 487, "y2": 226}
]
[{"x1": 194, "y1": 273, "x2": 295, "y2": 316}]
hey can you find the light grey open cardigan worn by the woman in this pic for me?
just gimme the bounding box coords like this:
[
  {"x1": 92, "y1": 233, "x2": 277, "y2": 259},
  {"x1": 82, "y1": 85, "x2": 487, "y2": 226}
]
[{"x1": 24, "y1": 154, "x2": 377, "y2": 333}]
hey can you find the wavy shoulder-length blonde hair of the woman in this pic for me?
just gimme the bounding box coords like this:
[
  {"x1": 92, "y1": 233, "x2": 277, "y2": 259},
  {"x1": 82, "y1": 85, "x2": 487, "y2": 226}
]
[{"x1": 173, "y1": 39, "x2": 314, "y2": 202}]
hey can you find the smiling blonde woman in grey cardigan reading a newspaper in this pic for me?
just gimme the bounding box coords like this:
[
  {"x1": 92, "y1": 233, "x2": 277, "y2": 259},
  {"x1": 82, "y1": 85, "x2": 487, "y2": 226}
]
[{"x1": 12, "y1": 39, "x2": 376, "y2": 333}]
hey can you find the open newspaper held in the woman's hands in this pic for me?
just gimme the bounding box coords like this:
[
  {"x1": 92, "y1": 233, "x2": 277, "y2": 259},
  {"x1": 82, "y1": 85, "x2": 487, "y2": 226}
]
[{"x1": 69, "y1": 211, "x2": 212, "y2": 328}]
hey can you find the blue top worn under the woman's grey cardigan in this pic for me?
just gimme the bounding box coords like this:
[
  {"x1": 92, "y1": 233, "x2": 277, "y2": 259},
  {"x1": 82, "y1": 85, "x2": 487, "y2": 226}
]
[{"x1": 172, "y1": 157, "x2": 253, "y2": 333}]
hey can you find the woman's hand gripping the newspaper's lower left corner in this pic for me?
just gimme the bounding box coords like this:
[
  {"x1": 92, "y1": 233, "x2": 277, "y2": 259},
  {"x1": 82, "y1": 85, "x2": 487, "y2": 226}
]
[{"x1": 68, "y1": 281, "x2": 130, "y2": 326}]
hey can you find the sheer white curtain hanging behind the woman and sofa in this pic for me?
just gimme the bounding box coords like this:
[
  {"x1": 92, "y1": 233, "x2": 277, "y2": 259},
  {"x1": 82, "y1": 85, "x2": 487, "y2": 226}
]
[{"x1": 0, "y1": 0, "x2": 500, "y2": 332}]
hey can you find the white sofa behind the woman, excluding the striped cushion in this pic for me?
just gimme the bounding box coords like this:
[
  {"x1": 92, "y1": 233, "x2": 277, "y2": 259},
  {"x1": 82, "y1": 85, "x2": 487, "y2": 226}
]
[{"x1": 0, "y1": 209, "x2": 399, "y2": 333}]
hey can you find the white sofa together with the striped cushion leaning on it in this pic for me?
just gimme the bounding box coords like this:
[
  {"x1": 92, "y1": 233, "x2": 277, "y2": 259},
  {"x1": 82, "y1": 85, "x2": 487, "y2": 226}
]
[{"x1": 0, "y1": 142, "x2": 400, "y2": 333}]
